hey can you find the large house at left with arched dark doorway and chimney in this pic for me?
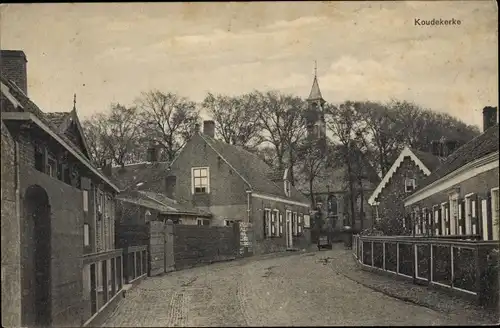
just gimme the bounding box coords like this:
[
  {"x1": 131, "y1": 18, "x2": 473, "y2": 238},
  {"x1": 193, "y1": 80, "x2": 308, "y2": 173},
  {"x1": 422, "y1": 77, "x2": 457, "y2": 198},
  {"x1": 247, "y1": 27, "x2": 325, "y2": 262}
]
[{"x1": 0, "y1": 50, "x2": 119, "y2": 327}]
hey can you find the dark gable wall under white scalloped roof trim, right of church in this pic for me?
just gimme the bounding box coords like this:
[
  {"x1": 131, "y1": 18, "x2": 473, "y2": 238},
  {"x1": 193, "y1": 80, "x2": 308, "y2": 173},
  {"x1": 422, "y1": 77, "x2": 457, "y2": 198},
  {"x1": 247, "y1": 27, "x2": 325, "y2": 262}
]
[{"x1": 378, "y1": 158, "x2": 425, "y2": 234}]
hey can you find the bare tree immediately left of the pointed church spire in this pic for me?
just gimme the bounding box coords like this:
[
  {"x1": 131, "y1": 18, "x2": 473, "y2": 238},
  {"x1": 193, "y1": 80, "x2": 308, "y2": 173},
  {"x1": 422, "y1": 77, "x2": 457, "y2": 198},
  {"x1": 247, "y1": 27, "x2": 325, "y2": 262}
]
[{"x1": 256, "y1": 91, "x2": 306, "y2": 183}]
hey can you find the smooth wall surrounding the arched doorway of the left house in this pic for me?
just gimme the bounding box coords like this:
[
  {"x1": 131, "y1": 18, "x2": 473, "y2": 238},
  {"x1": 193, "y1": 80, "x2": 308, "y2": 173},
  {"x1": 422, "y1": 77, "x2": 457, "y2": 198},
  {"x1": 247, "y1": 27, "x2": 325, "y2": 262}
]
[{"x1": 20, "y1": 165, "x2": 83, "y2": 326}]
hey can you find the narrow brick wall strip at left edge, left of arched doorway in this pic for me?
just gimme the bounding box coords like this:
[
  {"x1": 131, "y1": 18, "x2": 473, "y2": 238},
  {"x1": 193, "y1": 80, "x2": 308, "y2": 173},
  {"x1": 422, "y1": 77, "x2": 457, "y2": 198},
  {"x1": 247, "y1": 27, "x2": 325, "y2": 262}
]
[{"x1": 1, "y1": 122, "x2": 21, "y2": 327}]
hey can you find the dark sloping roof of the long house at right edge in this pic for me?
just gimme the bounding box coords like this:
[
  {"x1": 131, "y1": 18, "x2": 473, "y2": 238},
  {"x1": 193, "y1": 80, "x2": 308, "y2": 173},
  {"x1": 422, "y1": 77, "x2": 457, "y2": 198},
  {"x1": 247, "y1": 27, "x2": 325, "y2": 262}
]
[{"x1": 414, "y1": 123, "x2": 498, "y2": 193}]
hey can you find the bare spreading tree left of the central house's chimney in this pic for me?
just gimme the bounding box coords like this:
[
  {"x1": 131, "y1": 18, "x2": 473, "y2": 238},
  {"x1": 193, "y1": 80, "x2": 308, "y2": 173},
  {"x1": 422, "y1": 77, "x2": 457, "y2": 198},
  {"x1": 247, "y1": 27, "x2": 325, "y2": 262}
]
[{"x1": 137, "y1": 90, "x2": 200, "y2": 161}]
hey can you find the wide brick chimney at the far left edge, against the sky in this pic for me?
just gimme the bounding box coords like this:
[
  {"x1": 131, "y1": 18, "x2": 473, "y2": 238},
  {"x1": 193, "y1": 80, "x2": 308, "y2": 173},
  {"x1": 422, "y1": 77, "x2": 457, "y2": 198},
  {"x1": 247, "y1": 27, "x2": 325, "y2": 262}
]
[{"x1": 0, "y1": 50, "x2": 28, "y2": 96}]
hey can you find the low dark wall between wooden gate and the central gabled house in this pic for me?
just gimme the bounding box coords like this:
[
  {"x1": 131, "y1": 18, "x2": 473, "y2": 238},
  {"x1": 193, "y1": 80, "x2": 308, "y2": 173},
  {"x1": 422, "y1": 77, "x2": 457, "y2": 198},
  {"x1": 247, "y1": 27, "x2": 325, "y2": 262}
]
[{"x1": 173, "y1": 225, "x2": 239, "y2": 269}]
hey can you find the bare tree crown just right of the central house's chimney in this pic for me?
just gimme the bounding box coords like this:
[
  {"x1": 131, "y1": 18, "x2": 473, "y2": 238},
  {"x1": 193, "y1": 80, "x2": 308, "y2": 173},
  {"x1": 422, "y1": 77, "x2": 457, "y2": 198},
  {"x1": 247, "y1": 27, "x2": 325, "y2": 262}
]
[{"x1": 202, "y1": 93, "x2": 262, "y2": 150}]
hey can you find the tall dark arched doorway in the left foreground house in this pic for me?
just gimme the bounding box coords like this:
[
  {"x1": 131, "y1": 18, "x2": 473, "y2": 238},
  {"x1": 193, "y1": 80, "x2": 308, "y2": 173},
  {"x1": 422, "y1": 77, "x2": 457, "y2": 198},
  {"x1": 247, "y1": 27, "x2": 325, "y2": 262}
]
[{"x1": 23, "y1": 185, "x2": 52, "y2": 326}]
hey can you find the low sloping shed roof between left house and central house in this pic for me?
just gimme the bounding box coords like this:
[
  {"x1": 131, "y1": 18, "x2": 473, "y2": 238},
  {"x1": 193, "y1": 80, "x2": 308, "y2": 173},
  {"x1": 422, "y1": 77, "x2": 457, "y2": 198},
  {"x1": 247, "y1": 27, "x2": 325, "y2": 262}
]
[{"x1": 117, "y1": 190, "x2": 211, "y2": 217}]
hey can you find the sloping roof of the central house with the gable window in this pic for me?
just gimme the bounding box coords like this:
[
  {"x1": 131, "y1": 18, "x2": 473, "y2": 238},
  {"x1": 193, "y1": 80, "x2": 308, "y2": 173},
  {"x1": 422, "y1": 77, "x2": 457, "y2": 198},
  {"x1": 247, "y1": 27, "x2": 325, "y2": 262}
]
[{"x1": 200, "y1": 134, "x2": 309, "y2": 203}]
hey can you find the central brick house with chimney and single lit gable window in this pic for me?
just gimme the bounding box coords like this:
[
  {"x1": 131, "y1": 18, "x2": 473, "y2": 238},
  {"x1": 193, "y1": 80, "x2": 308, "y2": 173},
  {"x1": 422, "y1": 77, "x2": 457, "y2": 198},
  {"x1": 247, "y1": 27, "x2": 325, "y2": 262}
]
[{"x1": 166, "y1": 121, "x2": 310, "y2": 254}]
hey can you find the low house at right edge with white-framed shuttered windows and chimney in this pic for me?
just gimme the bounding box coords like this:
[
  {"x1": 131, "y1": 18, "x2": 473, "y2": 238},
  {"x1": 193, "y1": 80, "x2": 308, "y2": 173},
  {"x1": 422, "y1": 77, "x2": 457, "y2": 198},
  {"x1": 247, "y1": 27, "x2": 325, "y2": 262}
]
[{"x1": 404, "y1": 107, "x2": 500, "y2": 240}]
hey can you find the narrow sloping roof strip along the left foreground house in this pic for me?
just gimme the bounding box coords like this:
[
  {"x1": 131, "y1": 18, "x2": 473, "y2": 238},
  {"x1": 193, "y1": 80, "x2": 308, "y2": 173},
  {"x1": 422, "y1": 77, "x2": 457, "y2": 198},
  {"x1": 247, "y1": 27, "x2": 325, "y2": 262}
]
[{"x1": 0, "y1": 76, "x2": 117, "y2": 190}]
